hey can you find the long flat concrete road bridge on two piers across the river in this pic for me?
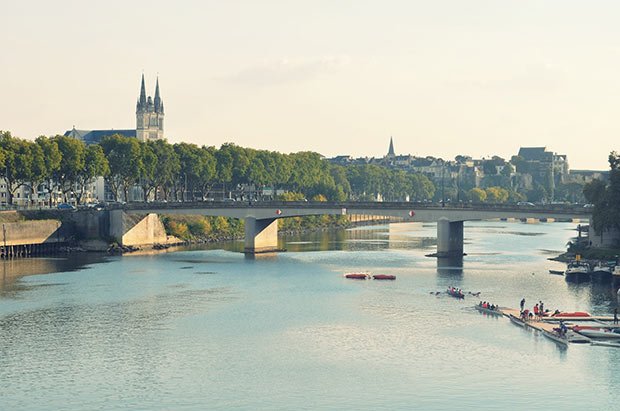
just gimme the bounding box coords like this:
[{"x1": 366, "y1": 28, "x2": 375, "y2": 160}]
[{"x1": 110, "y1": 201, "x2": 591, "y2": 257}]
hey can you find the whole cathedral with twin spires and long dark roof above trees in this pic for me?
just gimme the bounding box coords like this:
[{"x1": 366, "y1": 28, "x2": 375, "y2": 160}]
[{"x1": 65, "y1": 74, "x2": 164, "y2": 144}]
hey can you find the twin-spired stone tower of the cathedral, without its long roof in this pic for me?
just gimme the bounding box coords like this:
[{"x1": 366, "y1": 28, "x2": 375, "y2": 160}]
[{"x1": 136, "y1": 74, "x2": 164, "y2": 141}]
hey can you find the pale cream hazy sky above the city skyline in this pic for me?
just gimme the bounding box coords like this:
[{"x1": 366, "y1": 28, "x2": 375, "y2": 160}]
[{"x1": 0, "y1": 0, "x2": 620, "y2": 169}]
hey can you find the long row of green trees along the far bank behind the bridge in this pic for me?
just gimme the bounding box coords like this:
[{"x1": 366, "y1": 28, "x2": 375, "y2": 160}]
[{"x1": 0, "y1": 132, "x2": 435, "y2": 204}]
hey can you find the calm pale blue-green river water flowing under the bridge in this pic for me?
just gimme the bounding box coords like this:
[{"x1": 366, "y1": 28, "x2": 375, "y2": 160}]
[{"x1": 0, "y1": 222, "x2": 620, "y2": 410}]
